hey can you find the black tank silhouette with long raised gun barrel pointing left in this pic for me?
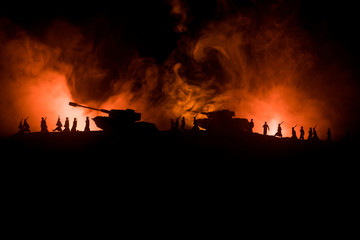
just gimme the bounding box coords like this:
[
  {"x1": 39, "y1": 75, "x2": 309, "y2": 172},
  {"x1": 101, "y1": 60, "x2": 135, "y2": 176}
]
[{"x1": 69, "y1": 102, "x2": 157, "y2": 133}]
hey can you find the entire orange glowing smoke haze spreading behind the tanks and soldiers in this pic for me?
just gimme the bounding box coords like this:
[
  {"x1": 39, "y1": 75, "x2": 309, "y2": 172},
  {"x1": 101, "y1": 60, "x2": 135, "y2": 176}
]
[{"x1": 0, "y1": 1, "x2": 358, "y2": 138}]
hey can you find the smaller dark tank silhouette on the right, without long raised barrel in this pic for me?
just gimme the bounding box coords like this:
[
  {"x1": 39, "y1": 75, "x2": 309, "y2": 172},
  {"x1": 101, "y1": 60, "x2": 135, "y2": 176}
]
[{"x1": 197, "y1": 109, "x2": 252, "y2": 133}]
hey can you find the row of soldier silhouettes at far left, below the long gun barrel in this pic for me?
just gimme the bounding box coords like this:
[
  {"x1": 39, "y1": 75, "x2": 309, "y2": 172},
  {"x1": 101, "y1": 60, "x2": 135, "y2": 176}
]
[{"x1": 18, "y1": 116, "x2": 90, "y2": 133}]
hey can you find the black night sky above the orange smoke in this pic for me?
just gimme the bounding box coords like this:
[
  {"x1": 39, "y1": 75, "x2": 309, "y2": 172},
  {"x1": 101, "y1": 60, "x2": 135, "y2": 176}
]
[{"x1": 0, "y1": 0, "x2": 360, "y2": 68}]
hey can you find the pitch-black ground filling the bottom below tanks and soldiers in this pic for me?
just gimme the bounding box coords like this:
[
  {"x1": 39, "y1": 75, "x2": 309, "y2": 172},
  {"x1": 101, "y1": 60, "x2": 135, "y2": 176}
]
[{"x1": 1, "y1": 132, "x2": 359, "y2": 234}]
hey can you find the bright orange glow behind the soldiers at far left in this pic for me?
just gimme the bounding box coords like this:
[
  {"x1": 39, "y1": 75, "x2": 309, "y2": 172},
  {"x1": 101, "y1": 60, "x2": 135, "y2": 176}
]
[{"x1": 0, "y1": 27, "x2": 98, "y2": 135}]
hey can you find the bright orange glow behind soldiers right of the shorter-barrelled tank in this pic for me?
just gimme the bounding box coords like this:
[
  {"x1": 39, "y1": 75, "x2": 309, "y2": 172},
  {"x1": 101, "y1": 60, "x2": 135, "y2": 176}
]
[{"x1": 228, "y1": 86, "x2": 330, "y2": 138}]
